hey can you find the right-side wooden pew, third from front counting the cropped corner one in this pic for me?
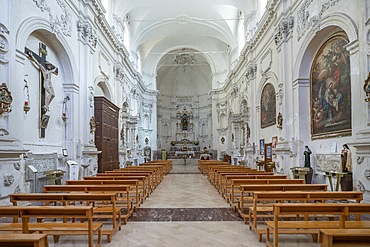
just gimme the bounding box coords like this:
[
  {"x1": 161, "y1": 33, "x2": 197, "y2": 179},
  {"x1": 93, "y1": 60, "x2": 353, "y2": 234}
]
[{"x1": 248, "y1": 191, "x2": 363, "y2": 242}]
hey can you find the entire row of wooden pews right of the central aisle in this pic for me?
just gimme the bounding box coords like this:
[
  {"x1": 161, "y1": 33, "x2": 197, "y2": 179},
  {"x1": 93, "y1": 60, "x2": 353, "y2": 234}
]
[{"x1": 198, "y1": 160, "x2": 370, "y2": 247}]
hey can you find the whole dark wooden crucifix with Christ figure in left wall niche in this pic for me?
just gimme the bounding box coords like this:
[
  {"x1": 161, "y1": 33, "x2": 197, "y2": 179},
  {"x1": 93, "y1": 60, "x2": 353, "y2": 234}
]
[{"x1": 25, "y1": 42, "x2": 58, "y2": 138}]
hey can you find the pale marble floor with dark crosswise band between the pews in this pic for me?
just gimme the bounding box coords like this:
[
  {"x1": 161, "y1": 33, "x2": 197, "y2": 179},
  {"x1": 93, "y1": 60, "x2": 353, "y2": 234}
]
[{"x1": 49, "y1": 160, "x2": 319, "y2": 247}]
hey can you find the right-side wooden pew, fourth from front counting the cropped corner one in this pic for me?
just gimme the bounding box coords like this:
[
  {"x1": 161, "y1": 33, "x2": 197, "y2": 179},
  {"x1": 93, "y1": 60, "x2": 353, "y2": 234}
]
[{"x1": 237, "y1": 184, "x2": 328, "y2": 223}]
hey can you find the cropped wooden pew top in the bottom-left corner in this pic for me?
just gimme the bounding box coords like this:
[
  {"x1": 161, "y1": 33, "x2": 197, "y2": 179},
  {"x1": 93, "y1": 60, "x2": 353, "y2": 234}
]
[{"x1": 0, "y1": 233, "x2": 49, "y2": 247}]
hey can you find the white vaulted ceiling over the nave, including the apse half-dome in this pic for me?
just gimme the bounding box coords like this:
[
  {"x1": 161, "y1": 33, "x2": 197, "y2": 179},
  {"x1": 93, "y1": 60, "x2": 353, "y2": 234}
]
[{"x1": 113, "y1": 0, "x2": 258, "y2": 94}]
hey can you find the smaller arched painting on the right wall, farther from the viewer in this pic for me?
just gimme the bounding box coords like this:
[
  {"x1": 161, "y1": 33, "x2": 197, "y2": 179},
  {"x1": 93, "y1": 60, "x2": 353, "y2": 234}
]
[{"x1": 261, "y1": 83, "x2": 276, "y2": 128}]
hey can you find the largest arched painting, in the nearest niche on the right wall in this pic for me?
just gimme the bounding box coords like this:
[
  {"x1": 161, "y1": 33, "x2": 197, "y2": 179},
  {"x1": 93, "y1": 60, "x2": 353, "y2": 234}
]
[{"x1": 310, "y1": 34, "x2": 352, "y2": 139}]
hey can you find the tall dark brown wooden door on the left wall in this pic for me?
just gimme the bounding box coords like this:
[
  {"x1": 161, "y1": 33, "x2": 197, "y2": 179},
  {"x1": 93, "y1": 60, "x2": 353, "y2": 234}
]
[{"x1": 94, "y1": 97, "x2": 119, "y2": 172}]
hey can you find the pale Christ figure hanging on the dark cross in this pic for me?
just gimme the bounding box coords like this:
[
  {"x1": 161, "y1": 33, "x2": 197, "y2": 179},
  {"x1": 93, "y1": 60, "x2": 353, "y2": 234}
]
[{"x1": 28, "y1": 53, "x2": 57, "y2": 113}]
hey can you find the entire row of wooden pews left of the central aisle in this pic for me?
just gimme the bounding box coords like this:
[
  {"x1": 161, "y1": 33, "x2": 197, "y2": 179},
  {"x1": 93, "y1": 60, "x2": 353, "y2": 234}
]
[{"x1": 0, "y1": 161, "x2": 172, "y2": 247}]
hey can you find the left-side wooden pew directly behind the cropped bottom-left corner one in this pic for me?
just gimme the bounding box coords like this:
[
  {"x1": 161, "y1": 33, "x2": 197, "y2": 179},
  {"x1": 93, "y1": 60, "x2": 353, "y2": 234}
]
[{"x1": 0, "y1": 206, "x2": 102, "y2": 247}]
